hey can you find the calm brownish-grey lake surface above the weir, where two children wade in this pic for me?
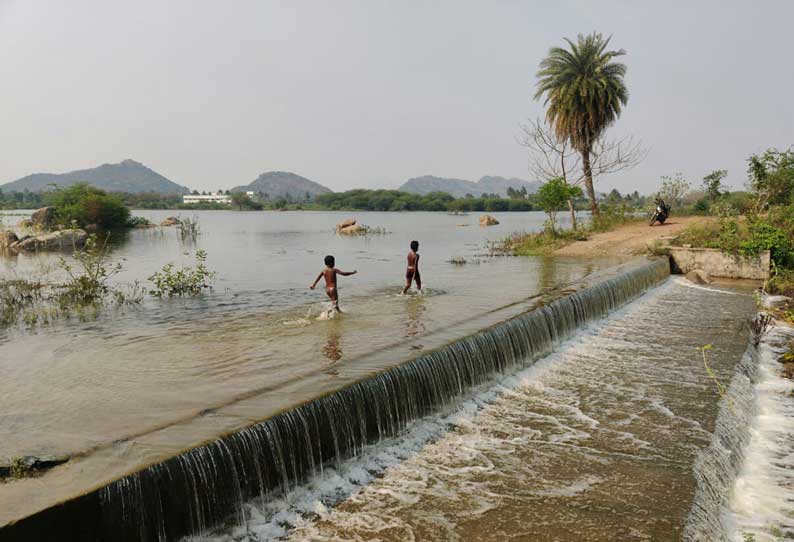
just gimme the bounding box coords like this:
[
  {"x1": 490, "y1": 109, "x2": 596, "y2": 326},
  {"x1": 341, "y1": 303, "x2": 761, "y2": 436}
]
[{"x1": 0, "y1": 211, "x2": 618, "y2": 522}]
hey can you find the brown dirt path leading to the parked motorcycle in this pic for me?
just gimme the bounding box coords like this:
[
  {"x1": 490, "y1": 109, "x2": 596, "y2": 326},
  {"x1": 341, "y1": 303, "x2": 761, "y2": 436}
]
[{"x1": 554, "y1": 216, "x2": 708, "y2": 256}]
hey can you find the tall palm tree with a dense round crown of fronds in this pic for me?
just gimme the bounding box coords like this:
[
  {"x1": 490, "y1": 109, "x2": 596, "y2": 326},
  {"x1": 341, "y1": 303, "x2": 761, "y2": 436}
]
[{"x1": 535, "y1": 32, "x2": 629, "y2": 216}]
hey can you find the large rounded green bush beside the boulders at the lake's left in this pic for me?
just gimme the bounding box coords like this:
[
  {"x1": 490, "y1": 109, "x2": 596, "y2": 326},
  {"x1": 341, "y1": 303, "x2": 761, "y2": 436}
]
[{"x1": 47, "y1": 183, "x2": 130, "y2": 230}]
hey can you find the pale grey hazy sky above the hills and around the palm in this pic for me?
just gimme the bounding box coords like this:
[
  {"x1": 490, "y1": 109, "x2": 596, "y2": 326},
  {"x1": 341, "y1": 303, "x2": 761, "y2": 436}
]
[{"x1": 0, "y1": 0, "x2": 794, "y2": 192}]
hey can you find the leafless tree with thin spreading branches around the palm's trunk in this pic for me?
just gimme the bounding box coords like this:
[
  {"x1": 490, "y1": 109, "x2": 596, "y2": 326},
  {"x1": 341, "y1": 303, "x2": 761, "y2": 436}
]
[{"x1": 518, "y1": 118, "x2": 648, "y2": 229}]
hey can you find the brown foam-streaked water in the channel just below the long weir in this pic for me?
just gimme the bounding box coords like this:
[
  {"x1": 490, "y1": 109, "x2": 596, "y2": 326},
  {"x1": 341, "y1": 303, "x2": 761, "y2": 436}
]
[{"x1": 190, "y1": 279, "x2": 754, "y2": 541}]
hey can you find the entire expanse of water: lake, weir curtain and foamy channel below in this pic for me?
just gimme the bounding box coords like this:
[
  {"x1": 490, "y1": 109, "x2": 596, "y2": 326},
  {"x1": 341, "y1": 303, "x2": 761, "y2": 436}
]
[{"x1": 0, "y1": 209, "x2": 780, "y2": 542}]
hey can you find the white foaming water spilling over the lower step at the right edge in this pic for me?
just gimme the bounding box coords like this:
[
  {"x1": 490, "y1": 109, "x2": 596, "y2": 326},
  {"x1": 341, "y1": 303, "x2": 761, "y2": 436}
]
[{"x1": 683, "y1": 320, "x2": 794, "y2": 542}]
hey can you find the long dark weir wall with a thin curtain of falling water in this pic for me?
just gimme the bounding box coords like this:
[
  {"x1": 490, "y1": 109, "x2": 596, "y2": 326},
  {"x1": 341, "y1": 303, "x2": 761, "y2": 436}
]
[{"x1": 0, "y1": 260, "x2": 669, "y2": 542}]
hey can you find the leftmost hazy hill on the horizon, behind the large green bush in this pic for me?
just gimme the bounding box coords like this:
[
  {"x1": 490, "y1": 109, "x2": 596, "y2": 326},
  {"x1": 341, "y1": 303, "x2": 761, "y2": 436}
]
[{"x1": 0, "y1": 160, "x2": 190, "y2": 194}]
